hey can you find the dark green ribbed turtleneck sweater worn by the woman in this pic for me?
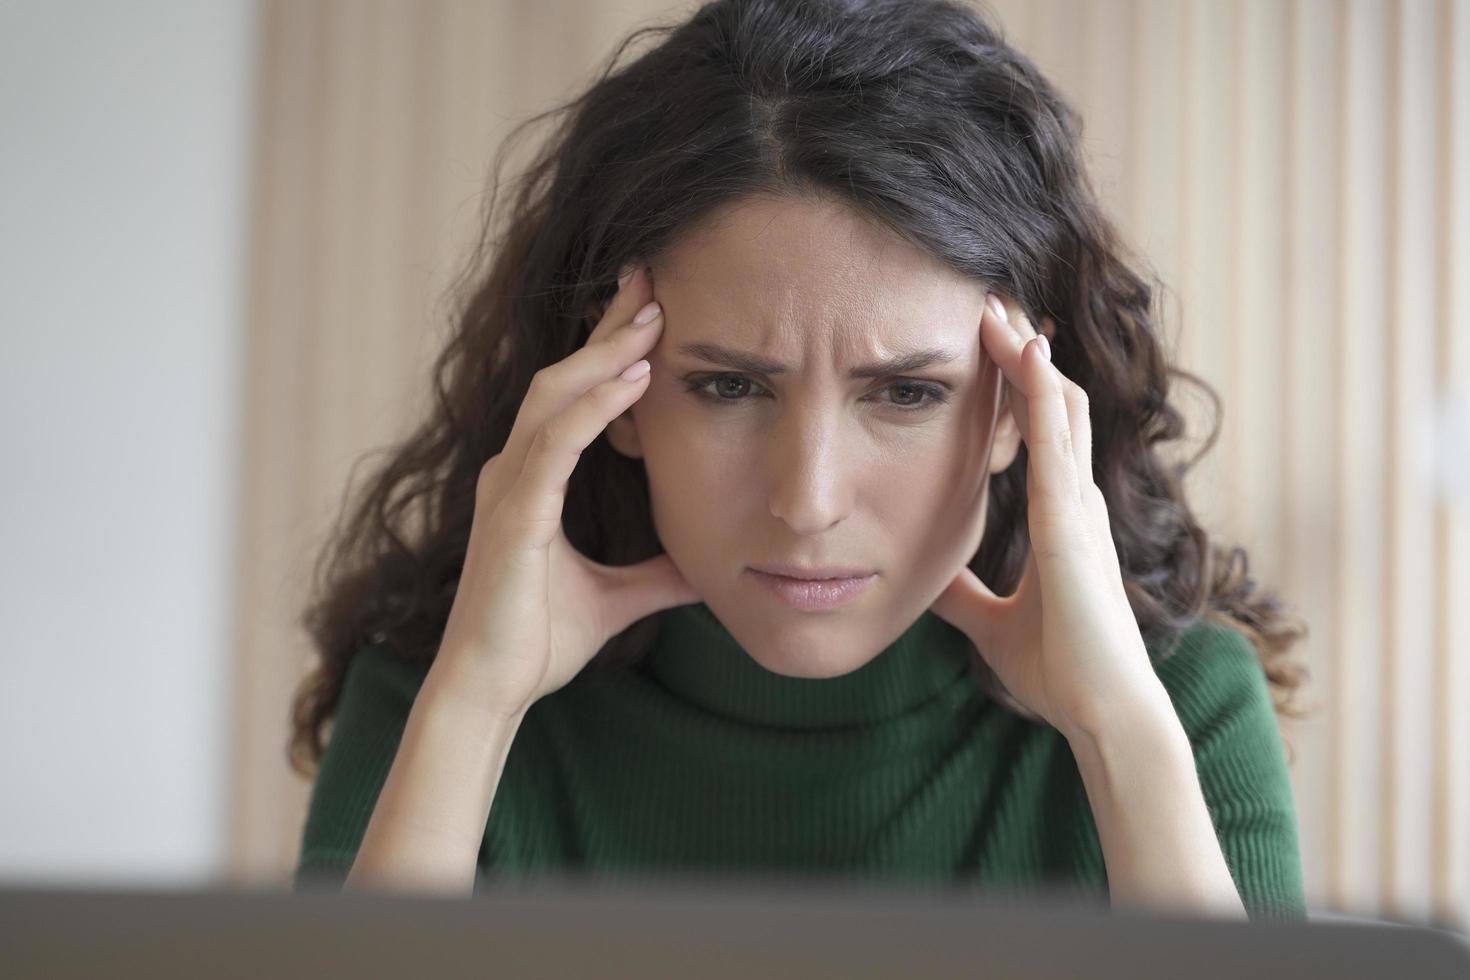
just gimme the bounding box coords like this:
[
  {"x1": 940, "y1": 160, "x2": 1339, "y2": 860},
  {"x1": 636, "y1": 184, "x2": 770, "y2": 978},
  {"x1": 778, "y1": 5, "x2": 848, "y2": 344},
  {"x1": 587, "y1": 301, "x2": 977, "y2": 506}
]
[{"x1": 295, "y1": 602, "x2": 1305, "y2": 918}]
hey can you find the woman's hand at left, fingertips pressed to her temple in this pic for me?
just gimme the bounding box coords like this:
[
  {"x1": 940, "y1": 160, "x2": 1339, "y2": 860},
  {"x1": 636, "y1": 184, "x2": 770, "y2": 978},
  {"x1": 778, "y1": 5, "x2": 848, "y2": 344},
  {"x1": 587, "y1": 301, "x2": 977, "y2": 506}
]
[{"x1": 440, "y1": 267, "x2": 700, "y2": 718}]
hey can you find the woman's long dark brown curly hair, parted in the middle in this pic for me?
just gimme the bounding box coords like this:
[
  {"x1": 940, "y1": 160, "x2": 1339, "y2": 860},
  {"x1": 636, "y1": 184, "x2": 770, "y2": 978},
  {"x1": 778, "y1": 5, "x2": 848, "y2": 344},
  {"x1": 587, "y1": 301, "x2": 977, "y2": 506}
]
[{"x1": 290, "y1": 0, "x2": 1308, "y2": 774}]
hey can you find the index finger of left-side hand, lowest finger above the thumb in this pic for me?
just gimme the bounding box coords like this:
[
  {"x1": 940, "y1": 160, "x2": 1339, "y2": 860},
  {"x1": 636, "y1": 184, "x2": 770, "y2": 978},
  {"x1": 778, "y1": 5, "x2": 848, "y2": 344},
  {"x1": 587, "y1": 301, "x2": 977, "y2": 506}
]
[{"x1": 495, "y1": 361, "x2": 651, "y2": 550}]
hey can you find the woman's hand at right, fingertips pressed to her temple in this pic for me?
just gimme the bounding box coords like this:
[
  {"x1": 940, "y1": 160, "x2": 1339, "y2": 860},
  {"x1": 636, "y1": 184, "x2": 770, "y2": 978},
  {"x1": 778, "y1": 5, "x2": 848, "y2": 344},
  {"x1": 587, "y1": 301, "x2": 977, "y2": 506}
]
[{"x1": 932, "y1": 294, "x2": 1167, "y2": 738}]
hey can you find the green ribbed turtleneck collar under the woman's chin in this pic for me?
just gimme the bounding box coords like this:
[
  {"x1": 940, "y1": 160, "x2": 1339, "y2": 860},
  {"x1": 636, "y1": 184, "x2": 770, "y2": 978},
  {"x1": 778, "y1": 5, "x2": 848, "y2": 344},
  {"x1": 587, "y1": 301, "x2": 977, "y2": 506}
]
[{"x1": 642, "y1": 602, "x2": 975, "y2": 729}]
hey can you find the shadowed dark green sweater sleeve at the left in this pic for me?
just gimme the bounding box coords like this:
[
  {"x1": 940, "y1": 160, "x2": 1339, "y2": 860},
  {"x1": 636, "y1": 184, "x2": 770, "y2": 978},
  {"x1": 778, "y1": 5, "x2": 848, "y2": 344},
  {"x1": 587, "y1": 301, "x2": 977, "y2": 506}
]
[{"x1": 293, "y1": 645, "x2": 428, "y2": 890}]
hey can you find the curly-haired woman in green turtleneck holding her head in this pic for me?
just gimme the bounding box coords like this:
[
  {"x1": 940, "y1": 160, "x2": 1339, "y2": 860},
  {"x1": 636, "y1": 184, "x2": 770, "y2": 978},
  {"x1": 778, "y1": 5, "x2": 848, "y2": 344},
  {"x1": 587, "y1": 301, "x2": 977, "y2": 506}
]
[{"x1": 293, "y1": 0, "x2": 1305, "y2": 917}]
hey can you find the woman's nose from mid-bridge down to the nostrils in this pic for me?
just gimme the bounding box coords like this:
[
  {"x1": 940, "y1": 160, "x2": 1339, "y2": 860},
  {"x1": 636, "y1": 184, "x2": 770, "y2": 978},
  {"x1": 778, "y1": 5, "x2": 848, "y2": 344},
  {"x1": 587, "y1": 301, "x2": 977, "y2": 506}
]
[{"x1": 767, "y1": 414, "x2": 854, "y2": 535}]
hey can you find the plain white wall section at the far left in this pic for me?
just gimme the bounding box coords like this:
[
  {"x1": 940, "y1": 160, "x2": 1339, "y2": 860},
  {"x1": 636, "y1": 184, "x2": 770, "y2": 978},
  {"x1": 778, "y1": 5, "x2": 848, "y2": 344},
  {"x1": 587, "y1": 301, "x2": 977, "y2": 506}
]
[{"x1": 0, "y1": 0, "x2": 256, "y2": 886}]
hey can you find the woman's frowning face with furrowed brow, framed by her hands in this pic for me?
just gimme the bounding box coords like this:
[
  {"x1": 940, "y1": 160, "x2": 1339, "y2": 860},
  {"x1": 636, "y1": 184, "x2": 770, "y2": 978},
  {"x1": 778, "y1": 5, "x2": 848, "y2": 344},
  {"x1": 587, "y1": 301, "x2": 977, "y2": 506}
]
[{"x1": 609, "y1": 197, "x2": 1019, "y2": 677}]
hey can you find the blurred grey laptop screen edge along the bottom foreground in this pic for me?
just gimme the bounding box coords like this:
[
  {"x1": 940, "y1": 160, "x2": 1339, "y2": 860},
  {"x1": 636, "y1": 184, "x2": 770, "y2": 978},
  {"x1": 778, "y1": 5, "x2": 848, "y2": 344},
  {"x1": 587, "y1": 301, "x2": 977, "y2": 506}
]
[{"x1": 0, "y1": 873, "x2": 1470, "y2": 980}]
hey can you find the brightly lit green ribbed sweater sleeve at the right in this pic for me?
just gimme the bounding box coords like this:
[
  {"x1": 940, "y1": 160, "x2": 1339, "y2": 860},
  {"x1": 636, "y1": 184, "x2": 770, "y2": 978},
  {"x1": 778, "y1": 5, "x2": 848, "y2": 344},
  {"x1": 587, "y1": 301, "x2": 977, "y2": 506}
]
[{"x1": 1157, "y1": 621, "x2": 1307, "y2": 920}]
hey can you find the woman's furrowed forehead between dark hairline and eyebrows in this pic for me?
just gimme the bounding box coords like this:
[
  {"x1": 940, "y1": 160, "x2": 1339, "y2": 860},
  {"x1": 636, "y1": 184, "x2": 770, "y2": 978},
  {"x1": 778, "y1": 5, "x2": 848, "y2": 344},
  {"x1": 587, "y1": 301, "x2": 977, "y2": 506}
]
[{"x1": 654, "y1": 197, "x2": 985, "y2": 363}]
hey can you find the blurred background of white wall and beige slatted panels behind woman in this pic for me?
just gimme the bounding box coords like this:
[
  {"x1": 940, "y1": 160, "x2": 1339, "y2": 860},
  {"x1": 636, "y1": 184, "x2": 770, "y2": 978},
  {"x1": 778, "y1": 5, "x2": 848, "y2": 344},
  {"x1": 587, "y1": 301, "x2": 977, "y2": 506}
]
[{"x1": 0, "y1": 0, "x2": 1470, "y2": 929}]
